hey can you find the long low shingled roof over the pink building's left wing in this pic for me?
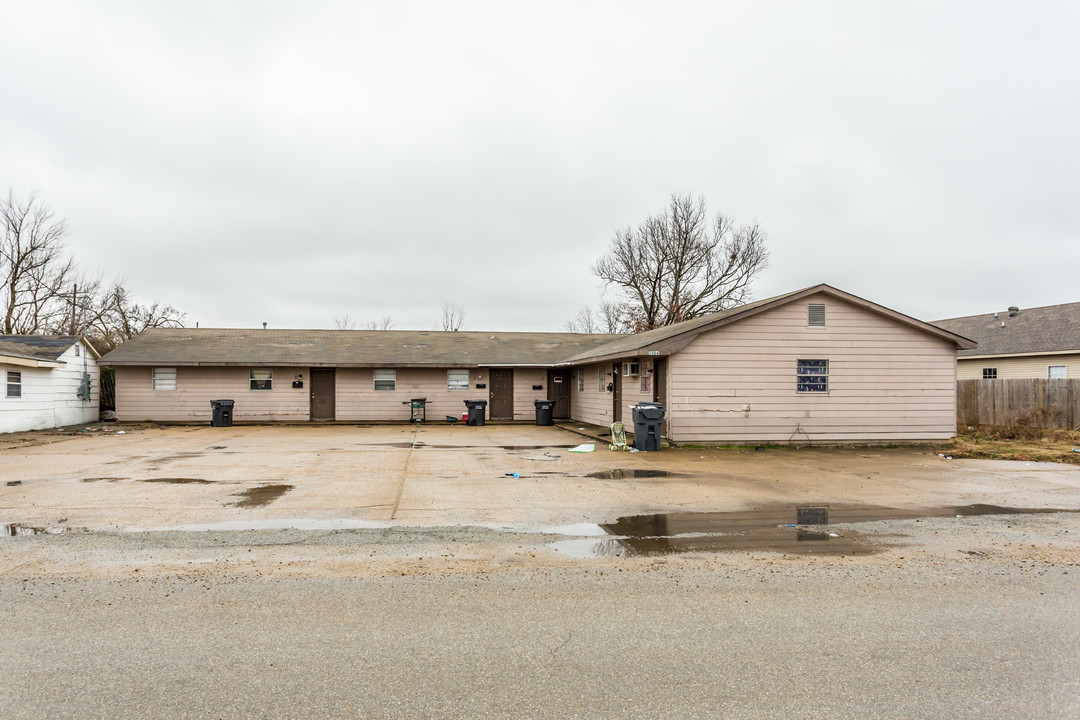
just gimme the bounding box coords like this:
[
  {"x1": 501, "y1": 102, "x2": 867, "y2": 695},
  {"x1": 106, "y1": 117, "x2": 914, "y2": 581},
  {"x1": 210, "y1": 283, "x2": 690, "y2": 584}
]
[{"x1": 103, "y1": 328, "x2": 619, "y2": 367}]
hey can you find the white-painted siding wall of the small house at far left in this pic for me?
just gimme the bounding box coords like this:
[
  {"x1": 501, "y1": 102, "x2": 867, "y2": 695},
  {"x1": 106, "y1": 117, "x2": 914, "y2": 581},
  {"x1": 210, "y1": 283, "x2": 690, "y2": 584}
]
[{"x1": 0, "y1": 345, "x2": 99, "y2": 433}]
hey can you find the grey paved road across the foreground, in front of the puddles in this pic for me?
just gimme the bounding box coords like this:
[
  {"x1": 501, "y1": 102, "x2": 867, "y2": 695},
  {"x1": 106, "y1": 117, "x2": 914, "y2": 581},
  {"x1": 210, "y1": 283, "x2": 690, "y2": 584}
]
[{"x1": 0, "y1": 557, "x2": 1080, "y2": 720}]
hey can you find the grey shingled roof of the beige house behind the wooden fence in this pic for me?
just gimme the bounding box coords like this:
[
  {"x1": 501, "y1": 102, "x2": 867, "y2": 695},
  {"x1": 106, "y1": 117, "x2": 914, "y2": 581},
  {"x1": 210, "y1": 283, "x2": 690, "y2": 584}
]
[{"x1": 933, "y1": 302, "x2": 1080, "y2": 357}]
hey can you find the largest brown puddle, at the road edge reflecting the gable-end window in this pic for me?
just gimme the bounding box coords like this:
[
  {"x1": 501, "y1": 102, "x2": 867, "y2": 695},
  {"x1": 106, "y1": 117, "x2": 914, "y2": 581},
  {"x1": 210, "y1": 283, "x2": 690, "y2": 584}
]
[{"x1": 543, "y1": 504, "x2": 1080, "y2": 558}]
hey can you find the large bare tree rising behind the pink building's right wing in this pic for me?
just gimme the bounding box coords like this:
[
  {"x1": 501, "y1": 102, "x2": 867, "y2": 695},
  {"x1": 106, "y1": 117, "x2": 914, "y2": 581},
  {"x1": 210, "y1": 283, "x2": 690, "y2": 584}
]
[{"x1": 593, "y1": 195, "x2": 769, "y2": 331}]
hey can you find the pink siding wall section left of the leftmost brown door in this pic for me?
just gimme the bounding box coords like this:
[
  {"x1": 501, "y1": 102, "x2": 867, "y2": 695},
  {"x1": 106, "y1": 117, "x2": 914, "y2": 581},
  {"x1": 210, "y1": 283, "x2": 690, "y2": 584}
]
[{"x1": 117, "y1": 366, "x2": 311, "y2": 422}]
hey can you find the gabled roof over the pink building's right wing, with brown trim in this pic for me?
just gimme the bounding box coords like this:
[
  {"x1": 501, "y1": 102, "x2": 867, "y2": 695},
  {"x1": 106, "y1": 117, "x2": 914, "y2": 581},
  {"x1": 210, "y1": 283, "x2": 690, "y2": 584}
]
[{"x1": 567, "y1": 284, "x2": 975, "y2": 364}]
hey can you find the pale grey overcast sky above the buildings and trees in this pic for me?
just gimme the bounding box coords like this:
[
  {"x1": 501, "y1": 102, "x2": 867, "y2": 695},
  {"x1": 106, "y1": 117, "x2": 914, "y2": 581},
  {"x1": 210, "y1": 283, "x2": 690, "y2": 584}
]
[{"x1": 0, "y1": 0, "x2": 1080, "y2": 330}]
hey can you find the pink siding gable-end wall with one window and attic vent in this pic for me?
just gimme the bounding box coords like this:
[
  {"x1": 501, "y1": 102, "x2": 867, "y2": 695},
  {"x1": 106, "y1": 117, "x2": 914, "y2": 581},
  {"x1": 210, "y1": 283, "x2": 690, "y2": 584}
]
[{"x1": 667, "y1": 295, "x2": 956, "y2": 444}]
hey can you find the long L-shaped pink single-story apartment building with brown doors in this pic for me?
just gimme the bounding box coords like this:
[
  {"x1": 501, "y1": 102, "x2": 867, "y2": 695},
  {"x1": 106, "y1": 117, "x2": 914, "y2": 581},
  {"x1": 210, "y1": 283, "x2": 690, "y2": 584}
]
[{"x1": 103, "y1": 285, "x2": 975, "y2": 444}]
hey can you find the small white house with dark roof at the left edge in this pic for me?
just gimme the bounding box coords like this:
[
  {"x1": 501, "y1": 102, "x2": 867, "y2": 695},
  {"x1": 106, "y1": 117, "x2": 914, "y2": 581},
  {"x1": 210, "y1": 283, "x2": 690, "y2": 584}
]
[{"x1": 0, "y1": 335, "x2": 100, "y2": 433}]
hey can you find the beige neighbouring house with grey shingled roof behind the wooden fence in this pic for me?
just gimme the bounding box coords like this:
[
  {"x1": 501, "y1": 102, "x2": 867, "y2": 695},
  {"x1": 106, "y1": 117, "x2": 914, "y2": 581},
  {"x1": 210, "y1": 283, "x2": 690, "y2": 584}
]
[{"x1": 933, "y1": 302, "x2": 1080, "y2": 380}]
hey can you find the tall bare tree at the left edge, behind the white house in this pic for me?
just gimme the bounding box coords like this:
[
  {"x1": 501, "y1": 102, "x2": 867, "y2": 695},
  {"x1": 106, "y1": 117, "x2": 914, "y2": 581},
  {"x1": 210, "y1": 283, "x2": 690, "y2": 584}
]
[{"x1": 0, "y1": 190, "x2": 75, "y2": 335}]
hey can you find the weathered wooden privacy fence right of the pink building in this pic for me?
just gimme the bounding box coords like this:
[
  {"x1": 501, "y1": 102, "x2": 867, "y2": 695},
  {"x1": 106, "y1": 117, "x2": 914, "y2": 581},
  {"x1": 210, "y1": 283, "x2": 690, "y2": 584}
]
[{"x1": 956, "y1": 378, "x2": 1080, "y2": 430}]
